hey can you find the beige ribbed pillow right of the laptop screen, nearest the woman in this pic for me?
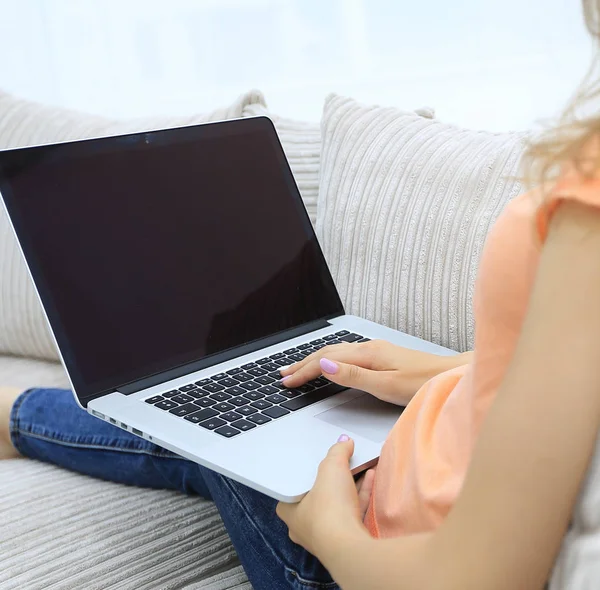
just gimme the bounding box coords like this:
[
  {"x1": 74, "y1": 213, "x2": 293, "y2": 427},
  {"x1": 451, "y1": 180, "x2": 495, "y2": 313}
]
[{"x1": 317, "y1": 95, "x2": 525, "y2": 351}]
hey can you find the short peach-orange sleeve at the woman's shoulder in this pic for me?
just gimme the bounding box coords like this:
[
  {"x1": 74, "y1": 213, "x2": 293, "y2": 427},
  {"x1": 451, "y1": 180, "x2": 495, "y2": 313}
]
[{"x1": 536, "y1": 174, "x2": 600, "y2": 242}]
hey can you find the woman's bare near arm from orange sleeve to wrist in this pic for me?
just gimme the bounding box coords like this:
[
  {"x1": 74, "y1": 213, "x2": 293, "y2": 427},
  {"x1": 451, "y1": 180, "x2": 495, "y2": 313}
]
[{"x1": 318, "y1": 203, "x2": 600, "y2": 590}]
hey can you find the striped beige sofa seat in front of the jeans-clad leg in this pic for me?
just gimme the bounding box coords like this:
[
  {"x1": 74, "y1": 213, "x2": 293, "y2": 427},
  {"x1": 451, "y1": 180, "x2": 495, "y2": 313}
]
[{"x1": 0, "y1": 459, "x2": 250, "y2": 590}]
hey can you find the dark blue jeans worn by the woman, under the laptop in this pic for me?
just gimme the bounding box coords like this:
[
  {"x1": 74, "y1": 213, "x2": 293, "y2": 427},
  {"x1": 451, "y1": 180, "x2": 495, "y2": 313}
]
[{"x1": 10, "y1": 389, "x2": 338, "y2": 590}]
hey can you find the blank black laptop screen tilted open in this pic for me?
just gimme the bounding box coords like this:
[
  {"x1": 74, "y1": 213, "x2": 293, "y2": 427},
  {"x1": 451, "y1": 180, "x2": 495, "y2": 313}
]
[{"x1": 0, "y1": 118, "x2": 344, "y2": 399}]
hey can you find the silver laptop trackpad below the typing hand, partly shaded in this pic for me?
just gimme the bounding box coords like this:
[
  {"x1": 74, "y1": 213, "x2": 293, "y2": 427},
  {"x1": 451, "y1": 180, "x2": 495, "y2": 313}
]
[{"x1": 315, "y1": 394, "x2": 404, "y2": 443}]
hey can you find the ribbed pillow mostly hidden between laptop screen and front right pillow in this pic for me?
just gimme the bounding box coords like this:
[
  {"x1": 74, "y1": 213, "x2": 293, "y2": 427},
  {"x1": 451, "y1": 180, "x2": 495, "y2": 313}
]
[{"x1": 244, "y1": 102, "x2": 435, "y2": 225}]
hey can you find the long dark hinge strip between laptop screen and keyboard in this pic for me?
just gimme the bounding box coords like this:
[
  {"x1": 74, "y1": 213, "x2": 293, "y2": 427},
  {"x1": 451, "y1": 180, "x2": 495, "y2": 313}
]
[{"x1": 117, "y1": 319, "x2": 330, "y2": 395}]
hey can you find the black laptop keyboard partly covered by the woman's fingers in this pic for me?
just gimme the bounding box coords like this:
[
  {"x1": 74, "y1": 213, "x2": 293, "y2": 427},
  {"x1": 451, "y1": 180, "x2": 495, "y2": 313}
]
[{"x1": 144, "y1": 330, "x2": 369, "y2": 438}]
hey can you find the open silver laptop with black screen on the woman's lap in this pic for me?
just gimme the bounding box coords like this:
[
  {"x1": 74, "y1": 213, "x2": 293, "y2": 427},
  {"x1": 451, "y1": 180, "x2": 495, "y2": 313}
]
[{"x1": 0, "y1": 117, "x2": 453, "y2": 502}]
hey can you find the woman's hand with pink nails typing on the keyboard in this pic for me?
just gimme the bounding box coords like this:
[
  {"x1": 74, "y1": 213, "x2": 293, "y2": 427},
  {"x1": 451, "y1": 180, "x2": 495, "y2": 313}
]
[{"x1": 281, "y1": 340, "x2": 471, "y2": 405}]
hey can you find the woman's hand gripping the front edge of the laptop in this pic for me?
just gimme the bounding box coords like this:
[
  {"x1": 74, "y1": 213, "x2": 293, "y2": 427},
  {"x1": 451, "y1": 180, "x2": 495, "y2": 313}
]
[{"x1": 277, "y1": 435, "x2": 375, "y2": 559}]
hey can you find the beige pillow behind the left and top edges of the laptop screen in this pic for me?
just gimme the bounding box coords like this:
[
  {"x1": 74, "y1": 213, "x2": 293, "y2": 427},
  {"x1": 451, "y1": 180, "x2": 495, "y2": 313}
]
[{"x1": 0, "y1": 91, "x2": 264, "y2": 360}]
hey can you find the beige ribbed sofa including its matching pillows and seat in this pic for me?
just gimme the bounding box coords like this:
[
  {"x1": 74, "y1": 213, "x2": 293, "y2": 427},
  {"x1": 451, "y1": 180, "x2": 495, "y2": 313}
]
[{"x1": 0, "y1": 91, "x2": 592, "y2": 590}]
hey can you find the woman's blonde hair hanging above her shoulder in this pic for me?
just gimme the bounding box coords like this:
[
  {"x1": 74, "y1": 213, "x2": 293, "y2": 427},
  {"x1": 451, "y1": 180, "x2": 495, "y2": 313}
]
[{"x1": 523, "y1": 0, "x2": 600, "y2": 186}]
